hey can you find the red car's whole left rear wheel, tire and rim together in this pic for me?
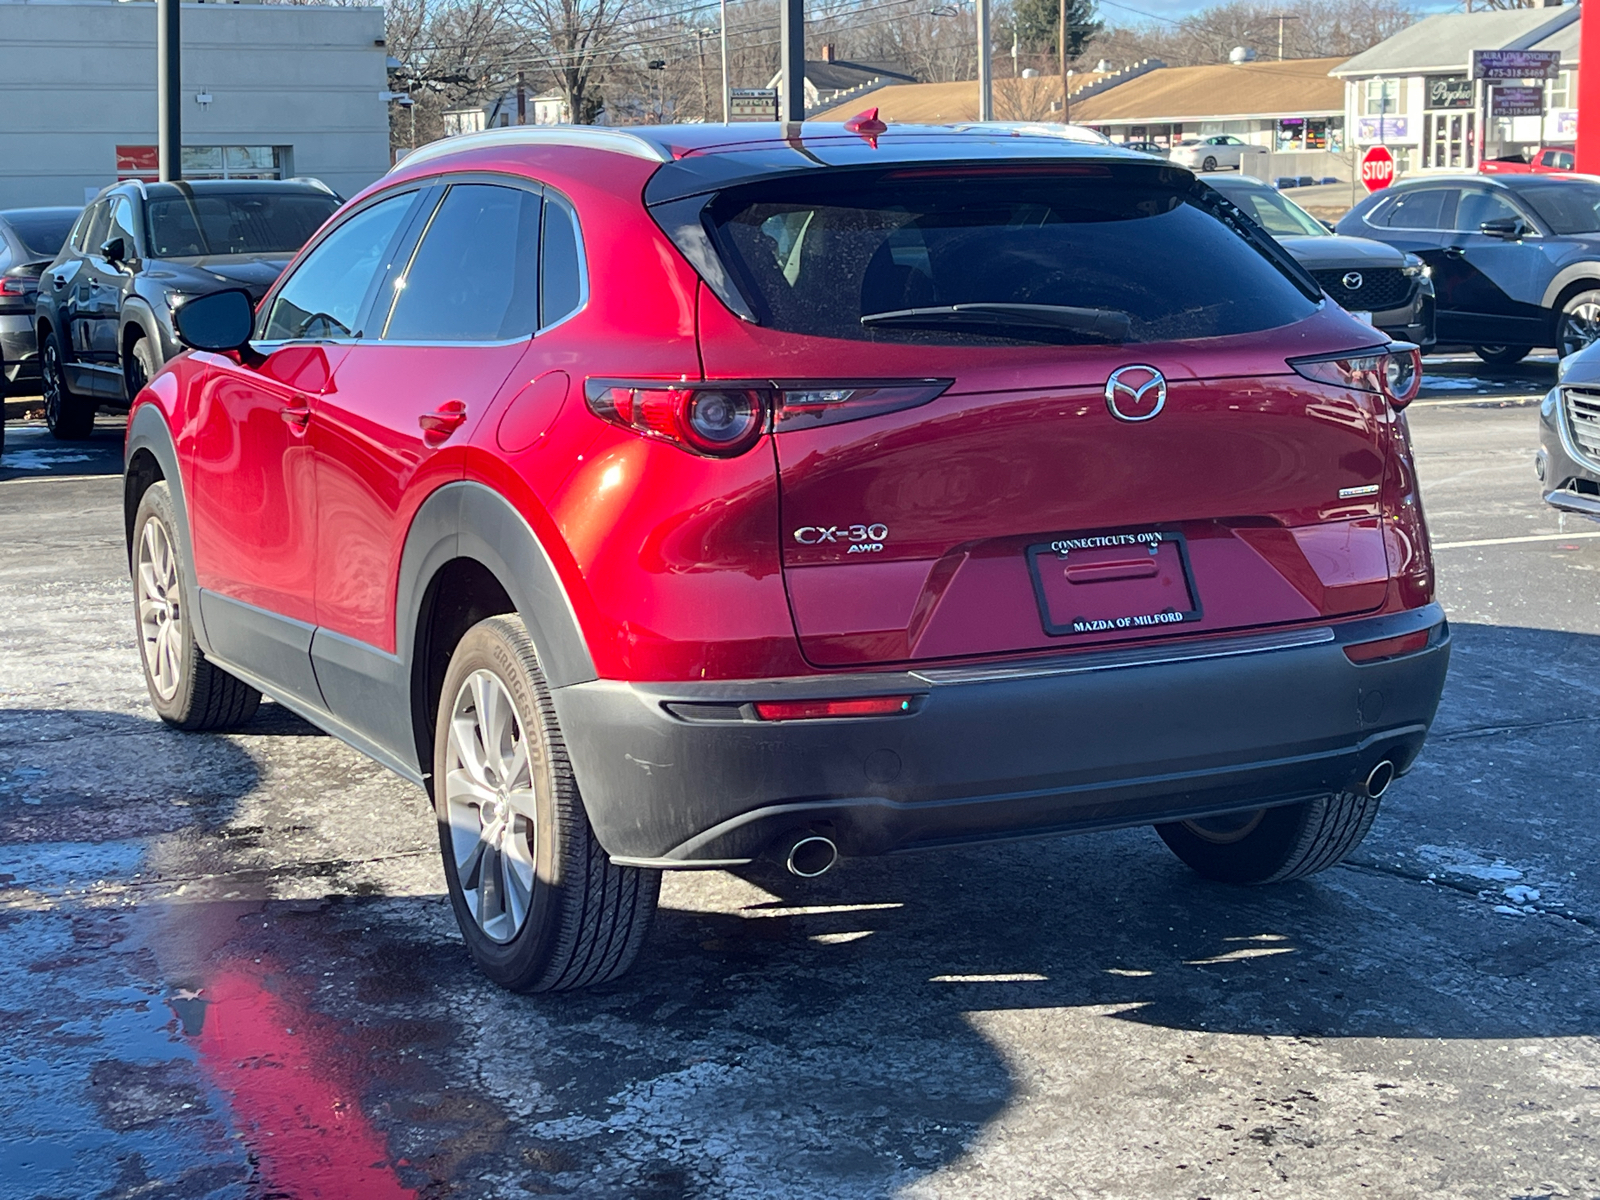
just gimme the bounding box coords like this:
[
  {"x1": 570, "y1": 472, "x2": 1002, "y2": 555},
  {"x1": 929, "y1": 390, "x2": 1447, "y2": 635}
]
[{"x1": 432, "y1": 616, "x2": 661, "y2": 992}]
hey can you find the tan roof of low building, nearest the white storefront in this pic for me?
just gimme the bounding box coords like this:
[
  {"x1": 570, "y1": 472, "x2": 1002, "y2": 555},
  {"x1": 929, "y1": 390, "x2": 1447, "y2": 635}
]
[{"x1": 1072, "y1": 58, "x2": 1344, "y2": 125}]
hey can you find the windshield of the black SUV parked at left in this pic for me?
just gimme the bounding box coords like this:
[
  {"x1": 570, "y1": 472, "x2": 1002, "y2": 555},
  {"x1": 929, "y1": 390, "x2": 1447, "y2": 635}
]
[{"x1": 146, "y1": 192, "x2": 339, "y2": 258}]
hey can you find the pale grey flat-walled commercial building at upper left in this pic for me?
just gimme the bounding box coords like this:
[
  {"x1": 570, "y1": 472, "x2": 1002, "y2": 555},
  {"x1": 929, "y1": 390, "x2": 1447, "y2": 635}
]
[{"x1": 0, "y1": 0, "x2": 389, "y2": 208}]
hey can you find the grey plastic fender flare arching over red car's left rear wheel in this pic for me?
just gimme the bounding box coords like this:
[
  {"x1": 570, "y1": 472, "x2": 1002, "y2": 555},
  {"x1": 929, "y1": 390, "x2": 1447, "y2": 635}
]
[{"x1": 395, "y1": 482, "x2": 597, "y2": 688}]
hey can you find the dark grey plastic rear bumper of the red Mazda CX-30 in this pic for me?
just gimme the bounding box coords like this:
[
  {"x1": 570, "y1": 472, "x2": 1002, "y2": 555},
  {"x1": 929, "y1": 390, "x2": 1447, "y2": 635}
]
[{"x1": 555, "y1": 605, "x2": 1450, "y2": 867}]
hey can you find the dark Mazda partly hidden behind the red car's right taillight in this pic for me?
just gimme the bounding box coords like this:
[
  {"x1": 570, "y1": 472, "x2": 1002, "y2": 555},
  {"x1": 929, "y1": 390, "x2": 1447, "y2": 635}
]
[{"x1": 1200, "y1": 174, "x2": 1434, "y2": 350}]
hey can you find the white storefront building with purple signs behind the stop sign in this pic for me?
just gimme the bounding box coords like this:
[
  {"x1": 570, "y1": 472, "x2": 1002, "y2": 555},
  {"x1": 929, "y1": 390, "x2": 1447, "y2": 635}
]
[{"x1": 1333, "y1": 5, "x2": 1579, "y2": 174}]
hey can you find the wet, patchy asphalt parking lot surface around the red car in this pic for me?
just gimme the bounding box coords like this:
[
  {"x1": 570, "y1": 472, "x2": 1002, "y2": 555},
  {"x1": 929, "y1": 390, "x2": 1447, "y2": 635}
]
[{"x1": 0, "y1": 358, "x2": 1600, "y2": 1200}]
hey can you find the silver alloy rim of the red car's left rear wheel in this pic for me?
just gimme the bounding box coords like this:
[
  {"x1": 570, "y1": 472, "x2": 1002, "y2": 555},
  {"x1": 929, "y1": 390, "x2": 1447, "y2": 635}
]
[{"x1": 445, "y1": 670, "x2": 538, "y2": 942}]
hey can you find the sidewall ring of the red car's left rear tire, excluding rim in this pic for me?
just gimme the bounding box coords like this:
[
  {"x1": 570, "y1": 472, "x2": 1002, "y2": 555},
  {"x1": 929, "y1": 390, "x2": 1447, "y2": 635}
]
[{"x1": 432, "y1": 618, "x2": 576, "y2": 987}]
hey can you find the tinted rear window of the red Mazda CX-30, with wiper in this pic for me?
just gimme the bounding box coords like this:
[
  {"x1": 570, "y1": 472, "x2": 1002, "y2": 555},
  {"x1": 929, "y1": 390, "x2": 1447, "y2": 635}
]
[{"x1": 709, "y1": 165, "x2": 1317, "y2": 344}]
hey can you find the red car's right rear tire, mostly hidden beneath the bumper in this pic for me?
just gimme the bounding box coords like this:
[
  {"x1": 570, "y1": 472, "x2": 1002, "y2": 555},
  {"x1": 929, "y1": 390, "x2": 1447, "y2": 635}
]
[{"x1": 1155, "y1": 792, "x2": 1378, "y2": 883}]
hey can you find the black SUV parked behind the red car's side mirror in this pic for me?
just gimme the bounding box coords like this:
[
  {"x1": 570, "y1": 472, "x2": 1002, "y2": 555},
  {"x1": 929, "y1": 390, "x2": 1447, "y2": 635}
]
[{"x1": 35, "y1": 179, "x2": 339, "y2": 438}]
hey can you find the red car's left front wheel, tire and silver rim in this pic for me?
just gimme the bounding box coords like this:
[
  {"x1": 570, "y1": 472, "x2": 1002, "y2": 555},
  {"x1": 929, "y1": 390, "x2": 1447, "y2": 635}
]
[{"x1": 130, "y1": 482, "x2": 261, "y2": 731}]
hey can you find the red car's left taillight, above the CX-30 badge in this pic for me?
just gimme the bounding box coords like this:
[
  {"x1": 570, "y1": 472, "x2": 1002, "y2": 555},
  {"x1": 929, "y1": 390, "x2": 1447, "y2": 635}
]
[{"x1": 584, "y1": 379, "x2": 954, "y2": 458}]
